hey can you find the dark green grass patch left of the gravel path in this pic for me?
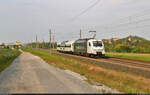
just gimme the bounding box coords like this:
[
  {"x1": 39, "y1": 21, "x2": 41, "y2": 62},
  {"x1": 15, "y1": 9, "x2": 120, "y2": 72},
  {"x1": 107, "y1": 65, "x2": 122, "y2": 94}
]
[{"x1": 0, "y1": 49, "x2": 20, "y2": 72}]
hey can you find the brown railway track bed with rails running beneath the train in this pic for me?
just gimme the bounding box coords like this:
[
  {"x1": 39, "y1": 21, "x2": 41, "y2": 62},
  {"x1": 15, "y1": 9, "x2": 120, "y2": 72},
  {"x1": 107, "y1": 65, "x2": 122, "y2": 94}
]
[{"x1": 35, "y1": 49, "x2": 150, "y2": 78}]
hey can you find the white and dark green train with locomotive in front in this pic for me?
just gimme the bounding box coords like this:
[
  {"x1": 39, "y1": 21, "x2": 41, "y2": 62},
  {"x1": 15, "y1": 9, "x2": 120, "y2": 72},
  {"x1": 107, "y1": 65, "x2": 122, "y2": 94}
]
[{"x1": 57, "y1": 38, "x2": 105, "y2": 57}]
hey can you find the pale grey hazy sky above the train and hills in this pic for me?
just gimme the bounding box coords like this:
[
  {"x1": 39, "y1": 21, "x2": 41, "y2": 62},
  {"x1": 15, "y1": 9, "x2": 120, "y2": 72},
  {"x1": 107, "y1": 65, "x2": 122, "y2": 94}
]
[{"x1": 0, "y1": 0, "x2": 150, "y2": 43}]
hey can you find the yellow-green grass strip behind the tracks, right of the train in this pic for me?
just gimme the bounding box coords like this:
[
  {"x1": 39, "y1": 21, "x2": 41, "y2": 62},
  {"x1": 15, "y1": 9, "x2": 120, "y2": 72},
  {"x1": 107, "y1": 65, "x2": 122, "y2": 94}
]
[{"x1": 106, "y1": 52, "x2": 150, "y2": 62}]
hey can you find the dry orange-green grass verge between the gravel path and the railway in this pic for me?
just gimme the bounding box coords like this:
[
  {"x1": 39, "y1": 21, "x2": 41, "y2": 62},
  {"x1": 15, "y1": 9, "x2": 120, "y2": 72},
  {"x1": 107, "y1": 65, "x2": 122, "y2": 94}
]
[{"x1": 23, "y1": 49, "x2": 150, "y2": 93}]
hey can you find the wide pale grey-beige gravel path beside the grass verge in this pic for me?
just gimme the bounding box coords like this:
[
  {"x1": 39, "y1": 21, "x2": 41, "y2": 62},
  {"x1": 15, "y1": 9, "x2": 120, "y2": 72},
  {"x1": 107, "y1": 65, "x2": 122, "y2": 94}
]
[{"x1": 0, "y1": 52, "x2": 99, "y2": 93}]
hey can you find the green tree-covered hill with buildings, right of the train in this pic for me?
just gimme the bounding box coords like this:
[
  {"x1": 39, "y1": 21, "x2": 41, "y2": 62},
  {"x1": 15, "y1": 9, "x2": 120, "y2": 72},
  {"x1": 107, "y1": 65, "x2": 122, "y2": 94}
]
[{"x1": 104, "y1": 36, "x2": 150, "y2": 53}]
